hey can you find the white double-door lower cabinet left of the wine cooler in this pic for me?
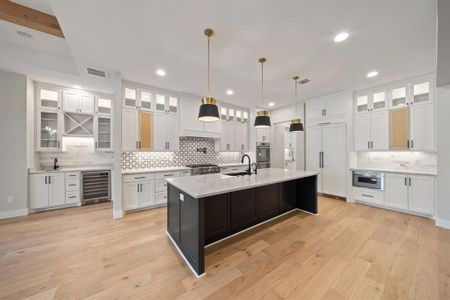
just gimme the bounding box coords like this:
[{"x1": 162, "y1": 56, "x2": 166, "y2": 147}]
[{"x1": 30, "y1": 172, "x2": 72, "y2": 209}]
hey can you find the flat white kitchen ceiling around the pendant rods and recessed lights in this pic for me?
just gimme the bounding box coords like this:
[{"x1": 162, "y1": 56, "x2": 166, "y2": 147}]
[{"x1": 0, "y1": 0, "x2": 436, "y2": 107}]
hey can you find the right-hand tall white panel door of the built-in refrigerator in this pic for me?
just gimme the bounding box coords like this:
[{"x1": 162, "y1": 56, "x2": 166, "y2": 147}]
[{"x1": 322, "y1": 124, "x2": 347, "y2": 197}]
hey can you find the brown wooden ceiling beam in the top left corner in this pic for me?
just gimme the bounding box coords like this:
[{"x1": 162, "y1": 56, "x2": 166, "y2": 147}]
[{"x1": 0, "y1": 0, "x2": 64, "y2": 38}]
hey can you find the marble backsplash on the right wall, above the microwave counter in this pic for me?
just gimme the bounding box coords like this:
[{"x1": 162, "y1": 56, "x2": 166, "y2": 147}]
[{"x1": 354, "y1": 151, "x2": 437, "y2": 170}]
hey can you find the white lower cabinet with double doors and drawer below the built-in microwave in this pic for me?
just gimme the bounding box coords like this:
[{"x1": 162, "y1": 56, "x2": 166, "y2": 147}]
[{"x1": 353, "y1": 173, "x2": 435, "y2": 216}]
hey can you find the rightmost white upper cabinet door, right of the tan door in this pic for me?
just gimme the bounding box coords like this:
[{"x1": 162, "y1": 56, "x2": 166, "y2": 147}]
[{"x1": 411, "y1": 104, "x2": 435, "y2": 151}]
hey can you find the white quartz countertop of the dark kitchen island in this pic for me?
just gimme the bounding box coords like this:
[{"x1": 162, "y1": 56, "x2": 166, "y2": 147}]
[{"x1": 166, "y1": 168, "x2": 318, "y2": 198}]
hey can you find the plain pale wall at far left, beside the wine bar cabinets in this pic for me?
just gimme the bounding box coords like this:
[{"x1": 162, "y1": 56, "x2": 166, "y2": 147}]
[{"x1": 0, "y1": 71, "x2": 28, "y2": 218}]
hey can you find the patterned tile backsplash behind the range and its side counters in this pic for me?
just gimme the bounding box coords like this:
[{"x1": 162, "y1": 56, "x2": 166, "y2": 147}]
[{"x1": 122, "y1": 137, "x2": 241, "y2": 170}]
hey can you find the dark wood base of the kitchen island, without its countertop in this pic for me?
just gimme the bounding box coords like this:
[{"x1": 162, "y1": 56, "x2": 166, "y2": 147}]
[{"x1": 167, "y1": 175, "x2": 317, "y2": 277}]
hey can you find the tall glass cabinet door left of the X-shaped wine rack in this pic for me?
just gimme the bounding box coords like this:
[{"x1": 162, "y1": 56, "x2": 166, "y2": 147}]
[{"x1": 39, "y1": 111, "x2": 61, "y2": 149}]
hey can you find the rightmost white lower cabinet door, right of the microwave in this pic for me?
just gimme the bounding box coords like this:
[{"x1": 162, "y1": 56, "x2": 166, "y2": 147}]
[{"x1": 408, "y1": 175, "x2": 435, "y2": 216}]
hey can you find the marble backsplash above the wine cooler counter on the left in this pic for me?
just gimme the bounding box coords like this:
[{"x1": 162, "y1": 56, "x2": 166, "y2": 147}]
[{"x1": 38, "y1": 137, "x2": 114, "y2": 168}]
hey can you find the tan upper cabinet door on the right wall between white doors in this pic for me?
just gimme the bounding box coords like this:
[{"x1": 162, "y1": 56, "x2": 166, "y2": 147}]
[{"x1": 389, "y1": 107, "x2": 409, "y2": 150}]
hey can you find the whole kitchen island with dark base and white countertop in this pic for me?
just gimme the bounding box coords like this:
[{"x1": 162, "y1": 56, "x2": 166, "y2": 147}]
[{"x1": 167, "y1": 168, "x2": 317, "y2": 276}]
